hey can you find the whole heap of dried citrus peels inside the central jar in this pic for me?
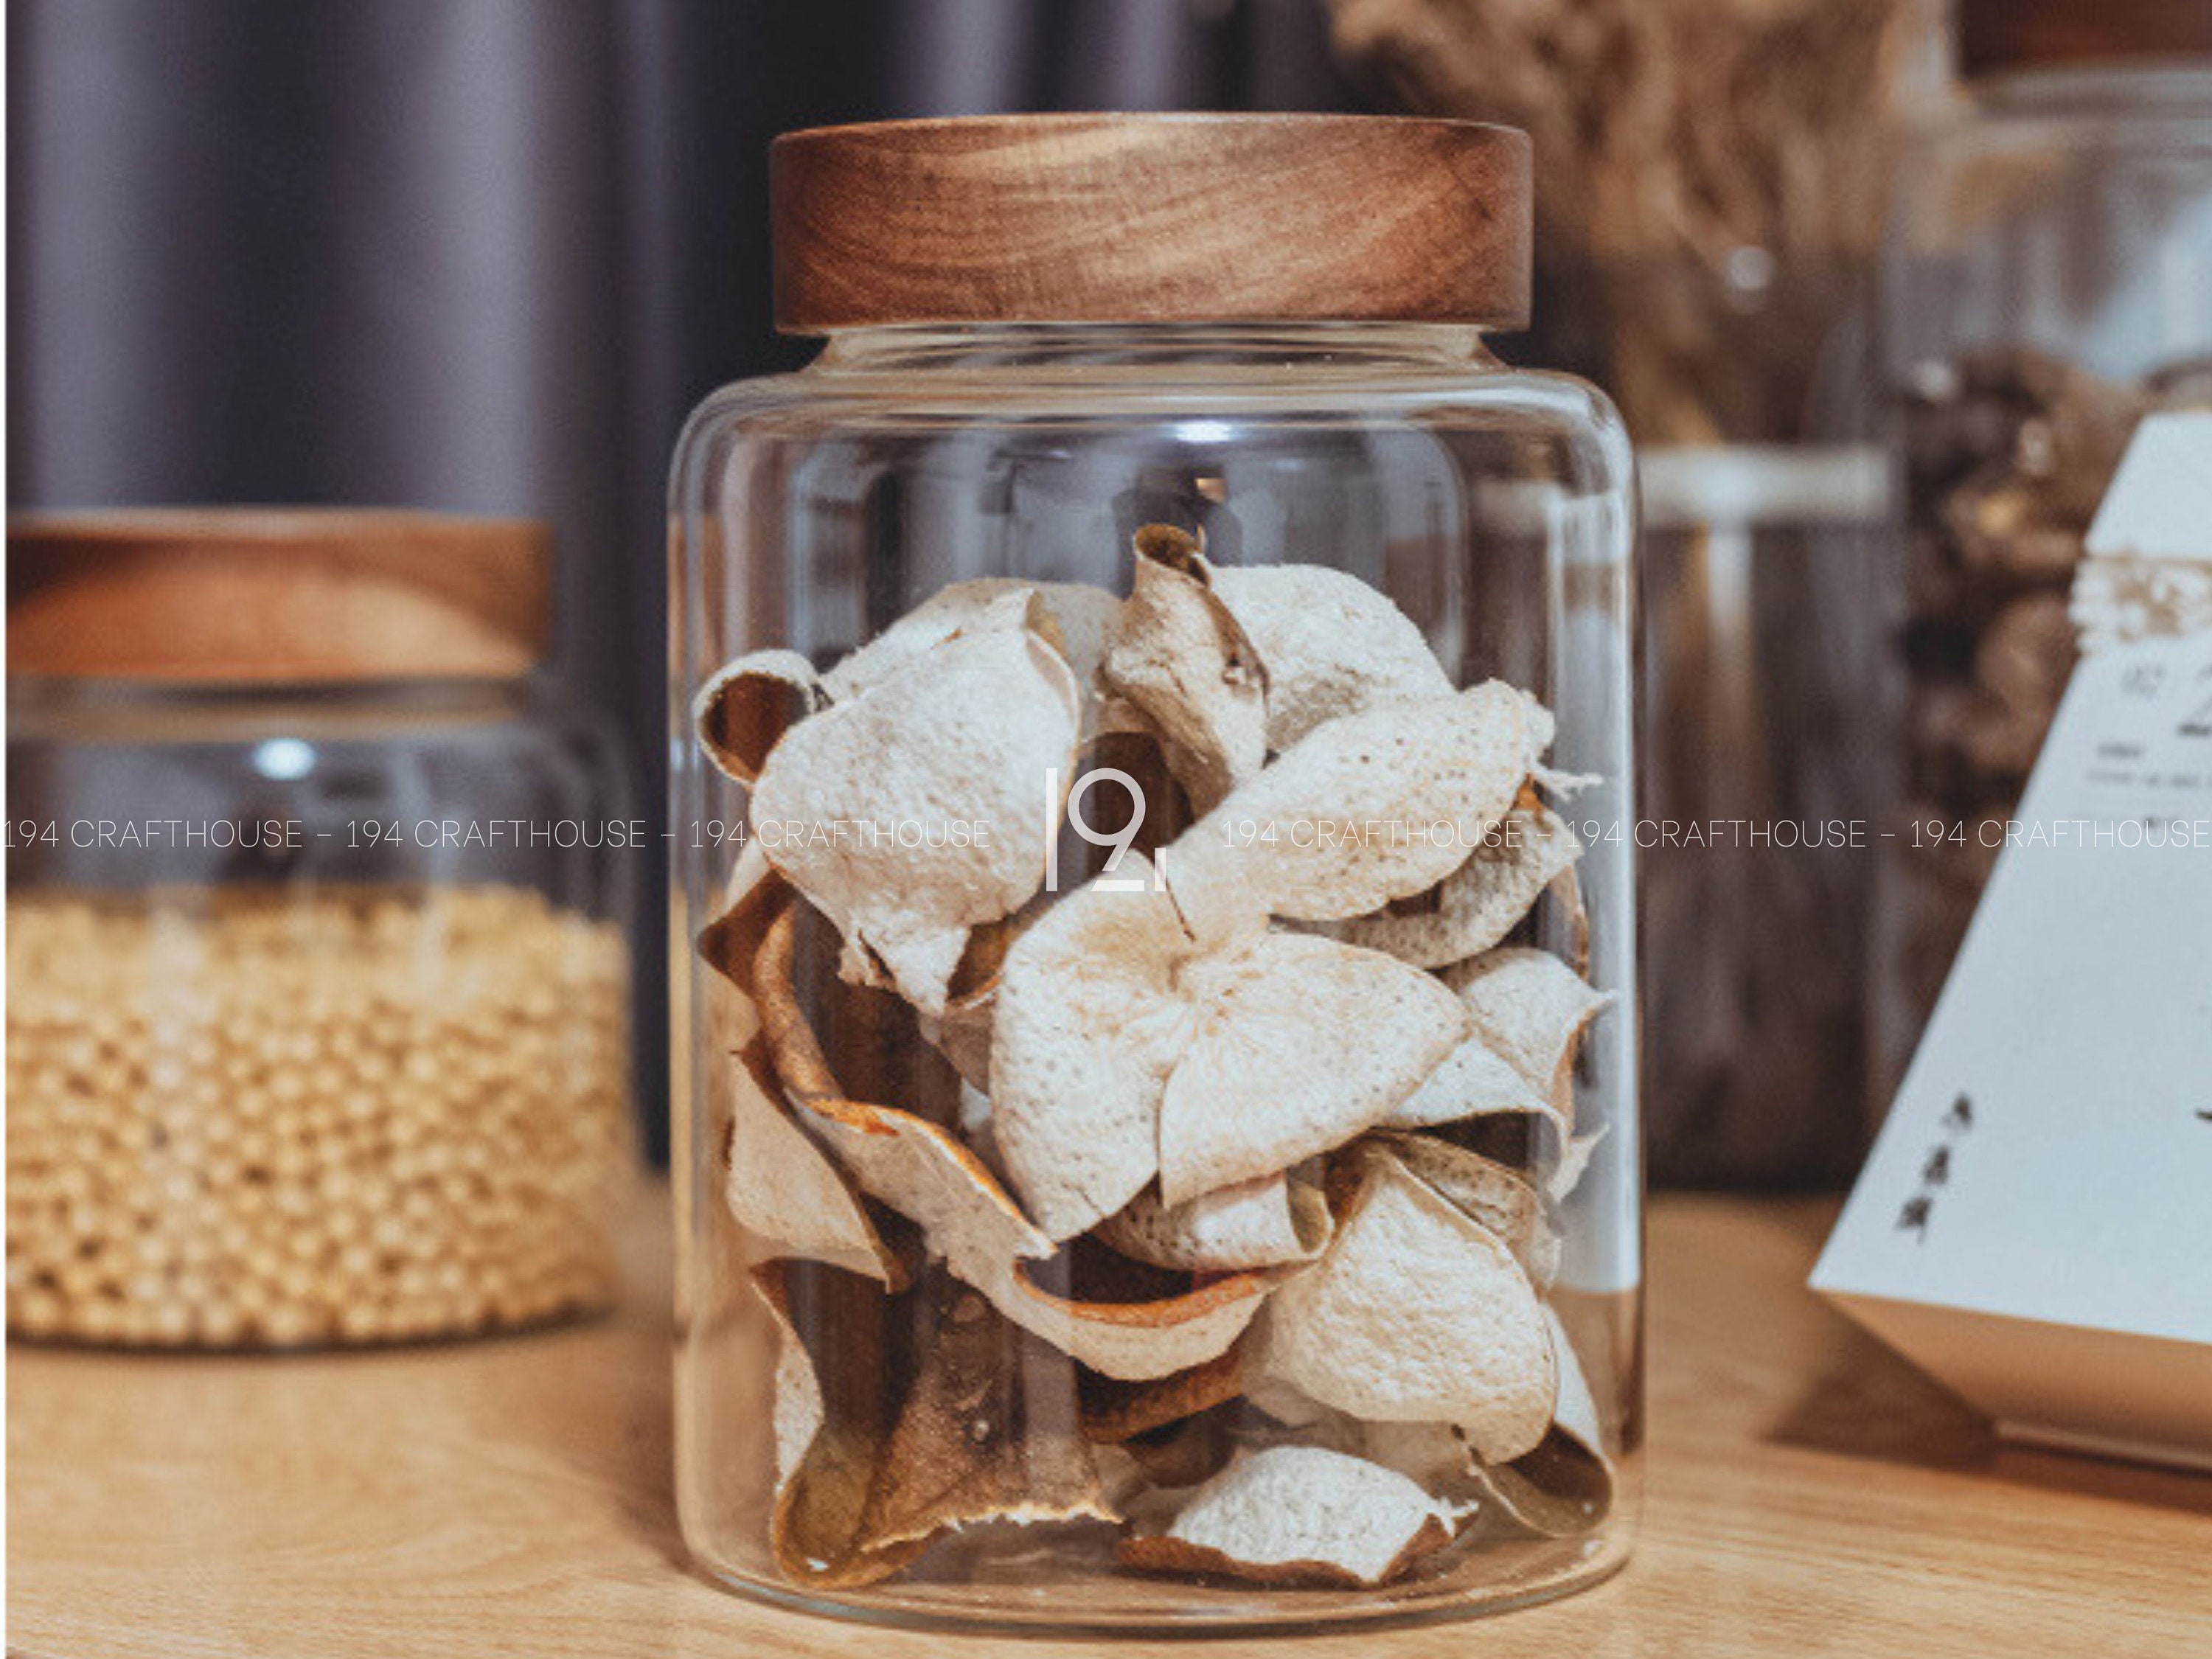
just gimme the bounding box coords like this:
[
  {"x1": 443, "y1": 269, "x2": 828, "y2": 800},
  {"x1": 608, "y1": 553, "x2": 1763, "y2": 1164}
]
[{"x1": 701, "y1": 560, "x2": 1606, "y2": 1588}]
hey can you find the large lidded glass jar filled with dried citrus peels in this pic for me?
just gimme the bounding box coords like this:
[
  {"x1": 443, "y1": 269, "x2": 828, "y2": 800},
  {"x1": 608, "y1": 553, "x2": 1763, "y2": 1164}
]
[{"x1": 670, "y1": 115, "x2": 1641, "y2": 1630}]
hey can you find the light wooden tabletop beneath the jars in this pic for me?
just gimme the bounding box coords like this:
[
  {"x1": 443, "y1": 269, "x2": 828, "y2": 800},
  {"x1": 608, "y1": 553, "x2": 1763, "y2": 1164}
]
[{"x1": 7, "y1": 1197, "x2": 2212, "y2": 1659}]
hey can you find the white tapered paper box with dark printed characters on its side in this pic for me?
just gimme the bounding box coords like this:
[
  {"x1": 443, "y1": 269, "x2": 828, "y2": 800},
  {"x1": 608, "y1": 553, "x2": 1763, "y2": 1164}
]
[{"x1": 1814, "y1": 635, "x2": 2212, "y2": 1464}]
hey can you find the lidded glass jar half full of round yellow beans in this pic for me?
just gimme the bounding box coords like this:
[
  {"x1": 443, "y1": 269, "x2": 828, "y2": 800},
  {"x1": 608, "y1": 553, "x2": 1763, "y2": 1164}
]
[{"x1": 7, "y1": 511, "x2": 637, "y2": 1347}]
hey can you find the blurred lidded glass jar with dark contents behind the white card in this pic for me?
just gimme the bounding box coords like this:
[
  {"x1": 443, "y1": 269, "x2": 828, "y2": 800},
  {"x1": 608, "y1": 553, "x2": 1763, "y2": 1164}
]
[{"x1": 1871, "y1": 0, "x2": 2212, "y2": 1099}]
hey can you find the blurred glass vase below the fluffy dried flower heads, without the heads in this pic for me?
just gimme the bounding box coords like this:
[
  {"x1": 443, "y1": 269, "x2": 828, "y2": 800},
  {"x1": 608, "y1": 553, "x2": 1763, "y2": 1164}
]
[{"x1": 1540, "y1": 257, "x2": 1896, "y2": 1188}]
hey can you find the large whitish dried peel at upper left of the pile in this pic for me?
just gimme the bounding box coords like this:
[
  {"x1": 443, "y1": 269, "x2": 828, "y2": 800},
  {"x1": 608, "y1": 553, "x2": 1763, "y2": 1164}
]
[{"x1": 752, "y1": 591, "x2": 1079, "y2": 1013}]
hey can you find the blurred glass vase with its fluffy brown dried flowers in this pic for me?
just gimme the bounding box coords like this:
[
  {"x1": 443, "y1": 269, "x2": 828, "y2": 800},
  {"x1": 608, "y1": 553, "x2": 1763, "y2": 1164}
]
[{"x1": 1329, "y1": 0, "x2": 1942, "y2": 1188}]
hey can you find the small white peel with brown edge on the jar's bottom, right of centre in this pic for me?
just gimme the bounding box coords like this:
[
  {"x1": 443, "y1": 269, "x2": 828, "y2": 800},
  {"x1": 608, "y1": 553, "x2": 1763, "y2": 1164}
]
[{"x1": 1121, "y1": 1447, "x2": 1460, "y2": 1586}]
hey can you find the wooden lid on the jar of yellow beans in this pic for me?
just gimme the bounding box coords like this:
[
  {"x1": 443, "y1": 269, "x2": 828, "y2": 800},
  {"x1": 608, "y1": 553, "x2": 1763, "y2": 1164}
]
[{"x1": 7, "y1": 507, "x2": 553, "y2": 684}]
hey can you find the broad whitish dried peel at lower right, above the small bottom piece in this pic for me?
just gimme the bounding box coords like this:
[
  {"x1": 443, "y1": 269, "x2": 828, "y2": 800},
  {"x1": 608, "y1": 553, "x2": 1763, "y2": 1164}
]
[{"x1": 1263, "y1": 1155, "x2": 1557, "y2": 1462}]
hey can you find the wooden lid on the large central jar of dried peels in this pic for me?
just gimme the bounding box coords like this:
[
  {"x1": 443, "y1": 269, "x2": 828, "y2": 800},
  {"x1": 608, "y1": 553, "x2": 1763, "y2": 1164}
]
[{"x1": 770, "y1": 115, "x2": 1531, "y2": 334}]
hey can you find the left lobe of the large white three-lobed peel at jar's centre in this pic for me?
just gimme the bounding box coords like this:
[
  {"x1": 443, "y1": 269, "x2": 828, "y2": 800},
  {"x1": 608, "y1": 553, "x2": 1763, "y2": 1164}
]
[{"x1": 991, "y1": 854, "x2": 1192, "y2": 1239}]
